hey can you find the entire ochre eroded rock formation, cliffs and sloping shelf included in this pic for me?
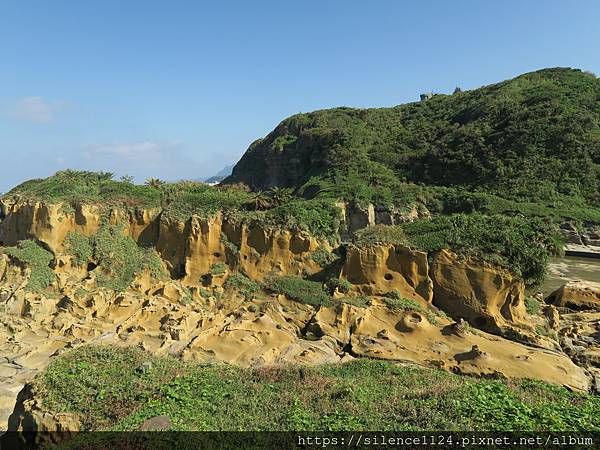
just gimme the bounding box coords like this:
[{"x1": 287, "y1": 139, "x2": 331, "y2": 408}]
[{"x1": 0, "y1": 202, "x2": 596, "y2": 430}]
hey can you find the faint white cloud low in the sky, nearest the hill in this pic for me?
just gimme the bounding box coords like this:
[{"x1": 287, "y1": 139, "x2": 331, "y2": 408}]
[{"x1": 85, "y1": 141, "x2": 182, "y2": 165}]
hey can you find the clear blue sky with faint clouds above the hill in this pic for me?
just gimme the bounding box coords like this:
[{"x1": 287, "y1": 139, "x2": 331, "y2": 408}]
[{"x1": 0, "y1": 0, "x2": 600, "y2": 192}]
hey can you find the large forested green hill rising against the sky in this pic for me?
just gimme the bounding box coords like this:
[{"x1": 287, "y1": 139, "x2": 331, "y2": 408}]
[{"x1": 225, "y1": 68, "x2": 600, "y2": 221}]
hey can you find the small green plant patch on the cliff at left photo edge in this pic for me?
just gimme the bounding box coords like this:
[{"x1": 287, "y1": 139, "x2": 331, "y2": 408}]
[{"x1": 0, "y1": 240, "x2": 55, "y2": 292}]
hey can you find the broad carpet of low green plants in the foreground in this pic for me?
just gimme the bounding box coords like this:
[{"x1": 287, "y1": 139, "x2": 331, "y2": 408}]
[{"x1": 35, "y1": 347, "x2": 600, "y2": 432}]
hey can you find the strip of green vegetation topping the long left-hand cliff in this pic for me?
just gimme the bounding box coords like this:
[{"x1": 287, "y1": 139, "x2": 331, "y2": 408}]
[{"x1": 5, "y1": 170, "x2": 341, "y2": 239}]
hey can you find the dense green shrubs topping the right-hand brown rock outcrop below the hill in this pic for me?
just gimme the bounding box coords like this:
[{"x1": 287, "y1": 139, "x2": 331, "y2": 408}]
[{"x1": 355, "y1": 213, "x2": 562, "y2": 286}]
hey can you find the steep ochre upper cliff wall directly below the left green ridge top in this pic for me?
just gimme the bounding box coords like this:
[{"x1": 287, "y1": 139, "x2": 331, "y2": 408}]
[{"x1": 0, "y1": 200, "x2": 331, "y2": 286}]
